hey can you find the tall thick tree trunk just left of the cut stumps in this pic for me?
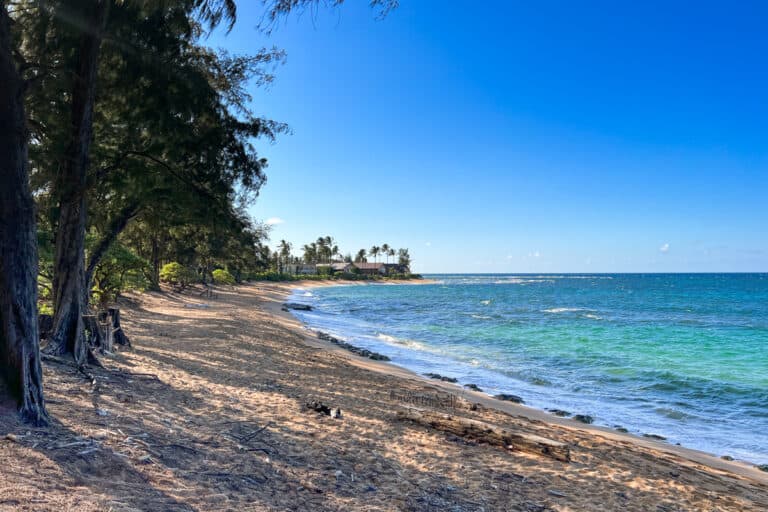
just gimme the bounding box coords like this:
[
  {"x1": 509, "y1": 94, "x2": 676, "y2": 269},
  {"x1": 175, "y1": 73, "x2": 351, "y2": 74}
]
[{"x1": 49, "y1": 0, "x2": 109, "y2": 363}]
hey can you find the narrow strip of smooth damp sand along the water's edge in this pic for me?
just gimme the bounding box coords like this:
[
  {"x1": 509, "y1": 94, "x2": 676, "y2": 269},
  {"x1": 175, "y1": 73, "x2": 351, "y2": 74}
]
[{"x1": 272, "y1": 280, "x2": 768, "y2": 483}]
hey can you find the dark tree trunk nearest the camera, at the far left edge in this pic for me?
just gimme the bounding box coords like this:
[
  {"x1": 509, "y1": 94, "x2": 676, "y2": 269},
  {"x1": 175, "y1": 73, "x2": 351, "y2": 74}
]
[{"x1": 0, "y1": 5, "x2": 48, "y2": 425}]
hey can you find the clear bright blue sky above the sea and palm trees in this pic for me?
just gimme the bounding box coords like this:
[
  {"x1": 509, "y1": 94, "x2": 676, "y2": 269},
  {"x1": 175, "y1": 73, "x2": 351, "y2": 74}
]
[{"x1": 209, "y1": 0, "x2": 768, "y2": 272}]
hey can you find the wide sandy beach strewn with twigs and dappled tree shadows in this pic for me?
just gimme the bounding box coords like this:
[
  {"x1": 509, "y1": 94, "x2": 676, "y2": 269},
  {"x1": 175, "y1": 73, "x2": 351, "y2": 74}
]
[{"x1": 0, "y1": 282, "x2": 768, "y2": 511}]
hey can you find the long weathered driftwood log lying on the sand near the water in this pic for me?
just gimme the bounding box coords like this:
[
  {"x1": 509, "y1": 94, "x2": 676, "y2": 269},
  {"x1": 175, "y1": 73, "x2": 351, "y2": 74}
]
[{"x1": 397, "y1": 409, "x2": 571, "y2": 462}]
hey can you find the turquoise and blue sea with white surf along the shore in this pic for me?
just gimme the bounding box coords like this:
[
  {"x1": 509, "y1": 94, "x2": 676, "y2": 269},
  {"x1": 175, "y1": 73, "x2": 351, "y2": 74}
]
[{"x1": 291, "y1": 274, "x2": 768, "y2": 464}]
